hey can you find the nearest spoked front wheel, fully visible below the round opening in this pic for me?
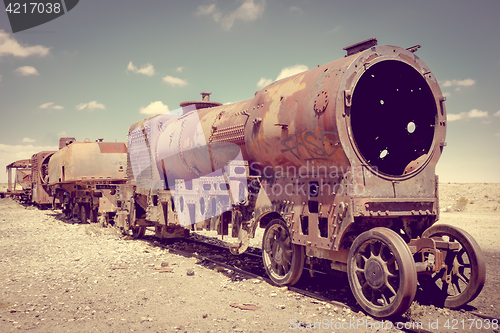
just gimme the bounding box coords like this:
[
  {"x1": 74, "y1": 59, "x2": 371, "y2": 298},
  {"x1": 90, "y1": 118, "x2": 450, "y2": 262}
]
[{"x1": 347, "y1": 227, "x2": 417, "y2": 317}]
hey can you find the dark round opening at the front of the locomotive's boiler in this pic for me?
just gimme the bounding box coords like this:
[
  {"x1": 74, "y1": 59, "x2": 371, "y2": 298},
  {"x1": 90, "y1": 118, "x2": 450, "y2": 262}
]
[{"x1": 351, "y1": 60, "x2": 437, "y2": 176}]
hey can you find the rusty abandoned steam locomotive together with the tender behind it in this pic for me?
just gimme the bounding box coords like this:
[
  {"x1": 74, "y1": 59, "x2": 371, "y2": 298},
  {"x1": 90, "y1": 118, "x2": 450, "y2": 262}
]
[{"x1": 5, "y1": 39, "x2": 486, "y2": 317}]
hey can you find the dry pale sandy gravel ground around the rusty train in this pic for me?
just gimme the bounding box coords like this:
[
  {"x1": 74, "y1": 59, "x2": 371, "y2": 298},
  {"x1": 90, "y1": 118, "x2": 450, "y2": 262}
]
[{"x1": 0, "y1": 184, "x2": 500, "y2": 332}]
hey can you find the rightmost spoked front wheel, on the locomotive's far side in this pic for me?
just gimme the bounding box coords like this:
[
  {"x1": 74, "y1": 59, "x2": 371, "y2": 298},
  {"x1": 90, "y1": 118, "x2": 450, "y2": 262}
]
[{"x1": 419, "y1": 224, "x2": 486, "y2": 309}]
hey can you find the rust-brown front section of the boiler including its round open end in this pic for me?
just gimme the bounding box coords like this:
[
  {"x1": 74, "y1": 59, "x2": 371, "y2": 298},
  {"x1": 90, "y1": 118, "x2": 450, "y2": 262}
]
[{"x1": 245, "y1": 40, "x2": 446, "y2": 179}]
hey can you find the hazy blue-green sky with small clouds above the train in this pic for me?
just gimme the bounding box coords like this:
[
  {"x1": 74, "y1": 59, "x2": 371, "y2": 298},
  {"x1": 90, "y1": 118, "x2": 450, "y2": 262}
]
[{"x1": 0, "y1": 0, "x2": 500, "y2": 182}]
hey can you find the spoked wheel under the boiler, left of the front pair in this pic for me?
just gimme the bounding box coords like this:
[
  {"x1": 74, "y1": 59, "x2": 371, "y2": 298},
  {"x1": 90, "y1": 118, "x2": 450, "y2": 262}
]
[{"x1": 262, "y1": 220, "x2": 304, "y2": 285}]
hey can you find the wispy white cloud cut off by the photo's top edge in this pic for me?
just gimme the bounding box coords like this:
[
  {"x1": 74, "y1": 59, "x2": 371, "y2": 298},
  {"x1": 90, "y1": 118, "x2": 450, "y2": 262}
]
[{"x1": 195, "y1": 0, "x2": 266, "y2": 31}]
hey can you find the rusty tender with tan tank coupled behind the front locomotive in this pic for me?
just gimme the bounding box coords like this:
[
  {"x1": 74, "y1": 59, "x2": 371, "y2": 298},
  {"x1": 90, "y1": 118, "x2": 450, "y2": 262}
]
[{"x1": 48, "y1": 138, "x2": 127, "y2": 225}]
